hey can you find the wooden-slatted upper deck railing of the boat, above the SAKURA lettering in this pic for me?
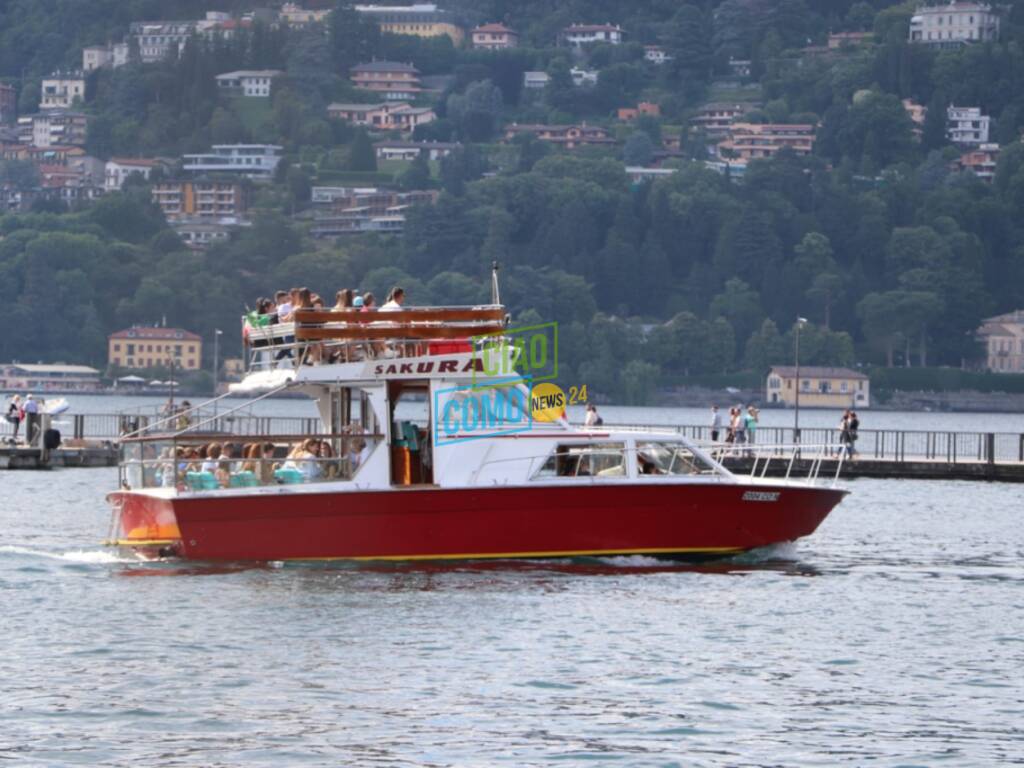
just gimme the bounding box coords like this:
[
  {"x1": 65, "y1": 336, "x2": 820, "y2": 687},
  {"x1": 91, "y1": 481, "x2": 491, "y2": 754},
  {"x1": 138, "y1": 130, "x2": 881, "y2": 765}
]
[{"x1": 244, "y1": 304, "x2": 508, "y2": 372}]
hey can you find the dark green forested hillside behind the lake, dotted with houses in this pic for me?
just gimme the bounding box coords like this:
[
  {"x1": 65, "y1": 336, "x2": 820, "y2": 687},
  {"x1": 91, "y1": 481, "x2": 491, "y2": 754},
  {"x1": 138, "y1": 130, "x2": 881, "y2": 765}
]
[{"x1": 0, "y1": 0, "x2": 1024, "y2": 402}]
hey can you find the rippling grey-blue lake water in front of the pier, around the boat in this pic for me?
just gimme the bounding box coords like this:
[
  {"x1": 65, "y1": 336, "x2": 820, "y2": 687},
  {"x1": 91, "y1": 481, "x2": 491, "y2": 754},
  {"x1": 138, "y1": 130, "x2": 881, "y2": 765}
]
[{"x1": 0, "y1": 466, "x2": 1024, "y2": 766}]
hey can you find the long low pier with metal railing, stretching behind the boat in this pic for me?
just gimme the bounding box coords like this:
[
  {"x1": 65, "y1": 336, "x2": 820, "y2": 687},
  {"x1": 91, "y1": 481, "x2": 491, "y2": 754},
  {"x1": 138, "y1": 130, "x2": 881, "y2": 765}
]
[{"x1": 0, "y1": 414, "x2": 1024, "y2": 482}]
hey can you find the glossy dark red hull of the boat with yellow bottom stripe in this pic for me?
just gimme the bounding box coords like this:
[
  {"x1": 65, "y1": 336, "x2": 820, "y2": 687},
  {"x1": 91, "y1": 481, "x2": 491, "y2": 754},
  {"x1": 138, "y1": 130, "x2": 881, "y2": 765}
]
[{"x1": 111, "y1": 481, "x2": 846, "y2": 560}]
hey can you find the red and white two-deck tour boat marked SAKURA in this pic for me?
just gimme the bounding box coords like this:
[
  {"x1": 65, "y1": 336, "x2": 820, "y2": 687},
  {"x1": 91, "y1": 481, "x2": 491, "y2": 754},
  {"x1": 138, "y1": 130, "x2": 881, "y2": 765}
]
[{"x1": 108, "y1": 290, "x2": 846, "y2": 561}]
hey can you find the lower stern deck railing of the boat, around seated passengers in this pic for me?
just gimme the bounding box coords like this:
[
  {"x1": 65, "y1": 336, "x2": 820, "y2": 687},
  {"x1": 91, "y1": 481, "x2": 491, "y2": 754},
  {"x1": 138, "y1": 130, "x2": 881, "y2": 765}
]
[{"x1": 119, "y1": 432, "x2": 384, "y2": 493}]
